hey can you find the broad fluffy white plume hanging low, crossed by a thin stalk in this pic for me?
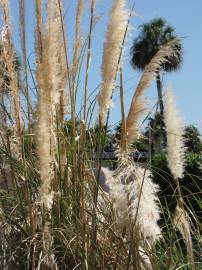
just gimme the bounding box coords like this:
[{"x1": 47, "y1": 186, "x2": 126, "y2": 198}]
[{"x1": 121, "y1": 164, "x2": 161, "y2": 243}]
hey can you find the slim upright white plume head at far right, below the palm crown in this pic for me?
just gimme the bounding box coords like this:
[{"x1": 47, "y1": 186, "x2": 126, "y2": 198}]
[{"x1": 164, "y1": 86, "x2": 185, "y2": 179}]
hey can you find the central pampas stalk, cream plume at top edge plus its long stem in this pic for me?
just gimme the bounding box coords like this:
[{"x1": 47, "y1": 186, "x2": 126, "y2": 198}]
[{"x1": 89, "y1": 1, "x2": 134, "y2": 254}]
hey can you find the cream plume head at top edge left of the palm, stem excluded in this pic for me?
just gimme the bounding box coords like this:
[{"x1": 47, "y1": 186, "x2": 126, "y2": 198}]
[{"x1": 99, "y1": 0, "x2": 129, "y2": 126}]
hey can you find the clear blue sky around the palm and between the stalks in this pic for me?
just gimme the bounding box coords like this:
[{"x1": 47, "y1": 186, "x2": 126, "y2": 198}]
[{"x1": 11, "y1": 0, "x2": 202, "y2": 131}]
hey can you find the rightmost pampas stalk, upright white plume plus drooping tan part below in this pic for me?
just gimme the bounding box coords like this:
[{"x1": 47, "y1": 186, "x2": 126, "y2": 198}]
[{"x1": 164, "y1": 86, "x2": 195, "y2": 269}]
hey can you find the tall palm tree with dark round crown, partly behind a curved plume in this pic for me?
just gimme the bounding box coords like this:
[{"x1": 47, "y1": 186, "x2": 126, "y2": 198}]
[{"x1": 131, "y1": 18, "x2": 182, "y2": 115}]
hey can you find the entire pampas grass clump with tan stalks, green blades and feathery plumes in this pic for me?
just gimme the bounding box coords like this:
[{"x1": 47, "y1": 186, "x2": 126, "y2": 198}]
[{"x1": 0, "y1": 0, "x2": 200, "y2": 270}]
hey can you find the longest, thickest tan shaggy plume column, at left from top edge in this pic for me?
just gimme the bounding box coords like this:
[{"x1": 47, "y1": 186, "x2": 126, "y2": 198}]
[{"x1": 37, "y1": 0, "x2": 66, "y2": 210}]
